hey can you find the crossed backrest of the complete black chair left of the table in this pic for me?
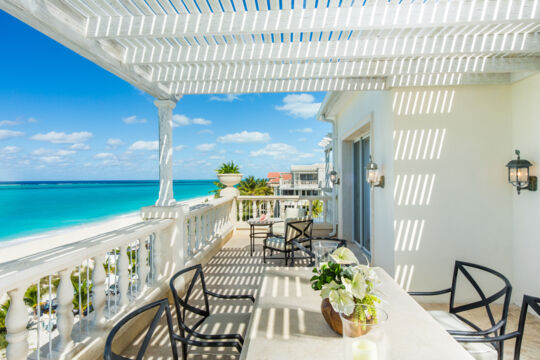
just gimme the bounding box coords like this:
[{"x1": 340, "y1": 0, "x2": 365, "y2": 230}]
[{"x1": 169, "y1": 264, "x2": 210, "y2": 337}]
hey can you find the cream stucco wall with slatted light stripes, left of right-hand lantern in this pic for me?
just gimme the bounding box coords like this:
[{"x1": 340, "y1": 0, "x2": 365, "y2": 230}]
[{"x1": 392, "y1": 86, "x2": 512, "y2": 301}]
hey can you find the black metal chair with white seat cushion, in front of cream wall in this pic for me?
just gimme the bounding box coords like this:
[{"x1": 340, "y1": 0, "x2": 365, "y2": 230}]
[{"x1": 409, "y1": 261, "x2": 512, "y2": 360}]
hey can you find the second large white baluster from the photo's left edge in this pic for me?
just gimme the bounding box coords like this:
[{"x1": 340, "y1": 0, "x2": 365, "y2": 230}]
[{"x1": 55, "y1": 269, "x2": 75, "y2": 352}]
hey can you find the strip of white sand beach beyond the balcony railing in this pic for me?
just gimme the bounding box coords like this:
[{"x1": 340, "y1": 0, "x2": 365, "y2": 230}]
[{"x1": 0, "y1": 196, "x2": 212, "y2": 264}]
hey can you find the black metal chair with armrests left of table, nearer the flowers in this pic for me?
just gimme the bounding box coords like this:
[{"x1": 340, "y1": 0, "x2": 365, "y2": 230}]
[{"x1": 169, "y1": 264, "x2": 255, "y2": 359}]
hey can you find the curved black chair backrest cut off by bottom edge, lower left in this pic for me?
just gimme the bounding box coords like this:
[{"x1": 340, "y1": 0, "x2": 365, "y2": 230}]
[{"x1": 103, "y1": 299, "x2": 178, "y2": 360}]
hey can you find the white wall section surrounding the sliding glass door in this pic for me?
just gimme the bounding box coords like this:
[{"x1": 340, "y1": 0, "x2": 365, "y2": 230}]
[{"x1": 329, "y1": 91, "x2": 394, "y2": 274}]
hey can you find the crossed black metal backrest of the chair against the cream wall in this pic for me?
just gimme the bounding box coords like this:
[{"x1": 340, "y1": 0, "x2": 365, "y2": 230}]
[{"x1": 450, "y1": 261, "x2": 512, "y2": 335}]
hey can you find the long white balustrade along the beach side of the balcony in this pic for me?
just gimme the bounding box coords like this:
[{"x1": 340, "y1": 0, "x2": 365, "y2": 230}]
[{"x1": 0, "y1": 197, "x2": 236, "y2": 360}]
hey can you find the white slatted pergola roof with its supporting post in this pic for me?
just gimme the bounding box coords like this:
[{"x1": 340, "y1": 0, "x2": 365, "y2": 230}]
[{"x1": 0, "y1": 0, "x2": 540, "y2": 205}]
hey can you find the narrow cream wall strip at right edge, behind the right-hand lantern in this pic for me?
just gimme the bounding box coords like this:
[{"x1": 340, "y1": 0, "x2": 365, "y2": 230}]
[{"x1": 512, "y1": 74, "x2": 540, "y2": 303}]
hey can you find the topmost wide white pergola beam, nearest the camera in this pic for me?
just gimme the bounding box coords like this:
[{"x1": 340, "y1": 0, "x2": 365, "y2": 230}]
[{"x1": 86, "y1": 0, "x2": 540, "y2": 39}]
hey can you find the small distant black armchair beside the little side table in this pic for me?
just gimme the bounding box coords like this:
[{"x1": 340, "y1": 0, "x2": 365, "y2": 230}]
[{"x1": 263, "y1": 219, "x2": 315, "y2": 266}]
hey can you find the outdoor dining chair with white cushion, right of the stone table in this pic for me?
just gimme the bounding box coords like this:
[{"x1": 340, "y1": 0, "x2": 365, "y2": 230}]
[{"x1": 409, "y1": 261, "x2": 512, "y2": 360}]
